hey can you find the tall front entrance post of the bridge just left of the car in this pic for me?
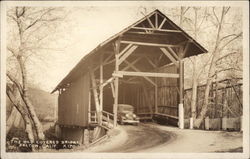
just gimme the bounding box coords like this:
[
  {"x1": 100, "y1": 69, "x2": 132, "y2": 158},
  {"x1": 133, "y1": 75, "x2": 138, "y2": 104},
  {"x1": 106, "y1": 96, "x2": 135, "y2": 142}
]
[{"x1": 113, "y1": 38, "x2": 120, "y2": 127}]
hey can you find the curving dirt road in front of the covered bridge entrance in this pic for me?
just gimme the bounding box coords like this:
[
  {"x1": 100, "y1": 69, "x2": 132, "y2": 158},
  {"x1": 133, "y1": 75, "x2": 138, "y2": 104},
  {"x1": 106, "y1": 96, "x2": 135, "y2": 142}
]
[{"x1": 85, "y1": 123, "x2": 242, "y2": 153}]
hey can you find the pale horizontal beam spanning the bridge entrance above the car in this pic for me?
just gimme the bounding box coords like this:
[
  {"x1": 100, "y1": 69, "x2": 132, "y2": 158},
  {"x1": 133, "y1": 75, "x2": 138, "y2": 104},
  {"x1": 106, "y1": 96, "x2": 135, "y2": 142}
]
[{"x1": 117, "y1": 71, "x2": 179, "y2": 78}]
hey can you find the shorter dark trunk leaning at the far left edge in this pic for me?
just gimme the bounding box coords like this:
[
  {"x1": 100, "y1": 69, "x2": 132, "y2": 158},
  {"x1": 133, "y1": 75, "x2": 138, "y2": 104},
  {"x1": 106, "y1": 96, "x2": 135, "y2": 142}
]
[{"x1": 6, "y1": 85, "x2": 34, "y2": 142}]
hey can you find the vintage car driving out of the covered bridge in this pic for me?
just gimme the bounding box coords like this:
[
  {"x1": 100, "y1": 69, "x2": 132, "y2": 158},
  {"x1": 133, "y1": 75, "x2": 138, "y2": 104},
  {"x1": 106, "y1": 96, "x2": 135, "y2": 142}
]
[{"x1": 117, "y1": 104, "x2": 139, "y2": 125}]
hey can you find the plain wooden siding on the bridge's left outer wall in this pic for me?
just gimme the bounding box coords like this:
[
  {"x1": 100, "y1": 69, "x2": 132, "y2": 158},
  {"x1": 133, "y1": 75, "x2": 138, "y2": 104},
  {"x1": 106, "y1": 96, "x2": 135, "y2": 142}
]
[{"x1": 58, "y1": 74, "x2": 90, "y2": 127}]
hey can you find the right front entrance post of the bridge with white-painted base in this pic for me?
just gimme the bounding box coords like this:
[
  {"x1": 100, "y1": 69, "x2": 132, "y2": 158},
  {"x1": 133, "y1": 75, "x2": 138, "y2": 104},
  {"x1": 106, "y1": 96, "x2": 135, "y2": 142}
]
[{"x1": 178, "y1": 60, "x2": 184, "y2": 129}]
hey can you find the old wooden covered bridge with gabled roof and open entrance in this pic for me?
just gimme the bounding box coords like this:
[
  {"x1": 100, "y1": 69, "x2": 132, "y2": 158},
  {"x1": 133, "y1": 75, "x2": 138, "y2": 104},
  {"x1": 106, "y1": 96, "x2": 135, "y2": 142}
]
[{"x1": 53, "y1": 10, "x2": 207, "y2": 142}]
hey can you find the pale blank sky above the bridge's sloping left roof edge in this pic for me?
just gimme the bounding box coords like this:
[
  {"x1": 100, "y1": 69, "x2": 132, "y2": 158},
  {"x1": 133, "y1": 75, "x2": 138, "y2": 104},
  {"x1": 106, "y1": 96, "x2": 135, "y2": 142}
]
[{"x1": 29, "y1": 6, "x2": 168, "y2": 91}]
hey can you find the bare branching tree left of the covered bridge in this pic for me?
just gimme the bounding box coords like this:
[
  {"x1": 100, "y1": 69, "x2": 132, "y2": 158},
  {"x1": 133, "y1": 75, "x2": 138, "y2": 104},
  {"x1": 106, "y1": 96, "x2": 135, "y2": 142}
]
[{"x1": 6, "y1": 7, "x2": 64, "y2": 142}]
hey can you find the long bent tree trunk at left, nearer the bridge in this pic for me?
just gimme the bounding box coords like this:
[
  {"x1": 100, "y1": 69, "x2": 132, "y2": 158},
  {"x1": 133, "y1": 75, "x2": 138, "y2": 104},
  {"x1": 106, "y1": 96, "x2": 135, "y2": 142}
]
[{"x1": 18, "y1": 57, "x2": 45, "y2": 140}]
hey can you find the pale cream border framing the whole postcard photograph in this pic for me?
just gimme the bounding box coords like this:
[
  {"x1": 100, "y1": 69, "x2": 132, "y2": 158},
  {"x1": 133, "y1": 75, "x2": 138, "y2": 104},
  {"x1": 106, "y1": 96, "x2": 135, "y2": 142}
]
[{"x1": 1, "y1": 1, "x2": 249, "y2": 159}]
